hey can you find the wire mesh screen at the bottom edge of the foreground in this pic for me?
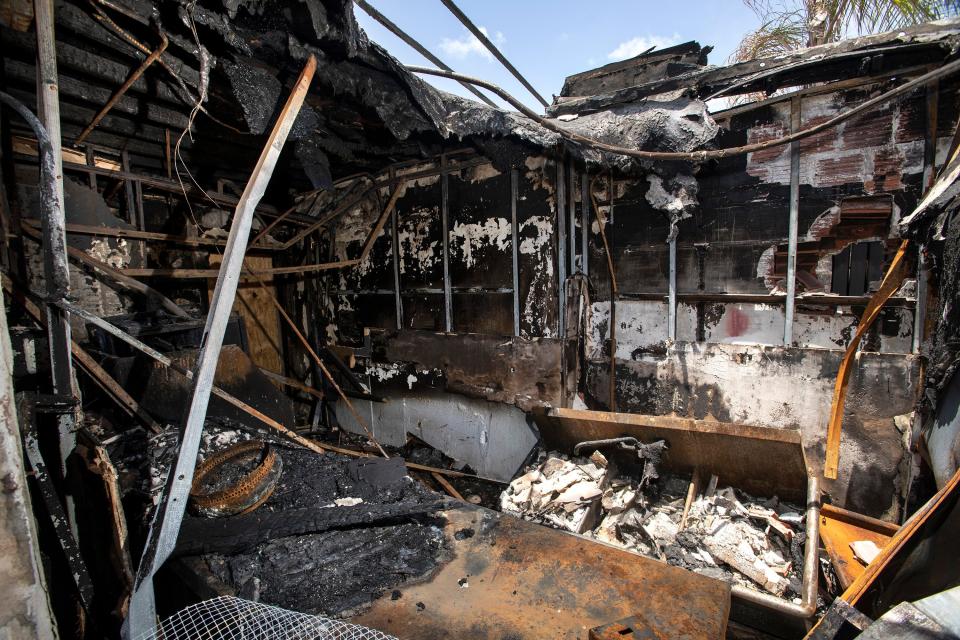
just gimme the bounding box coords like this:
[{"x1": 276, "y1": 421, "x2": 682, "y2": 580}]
[{"x1": 138, "y1": 596, "x2": 397, "y2": 640}]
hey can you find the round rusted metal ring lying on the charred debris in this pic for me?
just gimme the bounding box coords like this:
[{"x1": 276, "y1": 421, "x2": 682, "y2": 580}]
[{"x1": 190, "y1": 440, "x2": 283, "y2": 517}]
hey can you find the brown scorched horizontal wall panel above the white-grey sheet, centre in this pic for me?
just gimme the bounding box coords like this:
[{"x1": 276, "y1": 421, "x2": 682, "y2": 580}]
[{"x1": 375, "y1": 331, "x2": 561, "y2": 409}]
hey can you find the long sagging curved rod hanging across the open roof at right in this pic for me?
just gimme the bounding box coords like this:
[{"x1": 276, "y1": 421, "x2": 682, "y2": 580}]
[{"x1": 407, "y1": 59, "x2": 960, "y2": 162}]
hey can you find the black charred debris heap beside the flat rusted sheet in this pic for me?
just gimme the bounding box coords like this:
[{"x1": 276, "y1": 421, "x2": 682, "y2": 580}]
[{"x1": 198, "y1": 447, "x2": 445, "y2": 615}]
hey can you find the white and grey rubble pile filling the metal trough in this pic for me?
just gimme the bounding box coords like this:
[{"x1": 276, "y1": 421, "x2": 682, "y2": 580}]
[{"x1": 500, "y1": 442, "x2": 805, "y2": 598}]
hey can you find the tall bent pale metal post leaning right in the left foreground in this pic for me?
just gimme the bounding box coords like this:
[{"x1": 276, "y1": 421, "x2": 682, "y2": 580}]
[{"x1": 124, "y1": 56, "x2": 317, "y2": 638}]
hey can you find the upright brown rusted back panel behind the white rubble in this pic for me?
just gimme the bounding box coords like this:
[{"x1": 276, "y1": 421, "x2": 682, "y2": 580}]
[{"x1": 536, "y1": 409, "x2": 807, "y2": 502}]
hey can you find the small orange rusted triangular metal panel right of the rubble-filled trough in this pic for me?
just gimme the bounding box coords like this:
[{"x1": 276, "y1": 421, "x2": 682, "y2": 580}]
[{"x1": 820, "y1": 504, "x2": 899, "y2": 589}]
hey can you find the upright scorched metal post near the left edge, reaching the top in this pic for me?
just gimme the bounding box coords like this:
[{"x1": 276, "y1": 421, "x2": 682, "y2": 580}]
[{"x1": 34, "y1": 0, "x2": 78, "y2": 480}]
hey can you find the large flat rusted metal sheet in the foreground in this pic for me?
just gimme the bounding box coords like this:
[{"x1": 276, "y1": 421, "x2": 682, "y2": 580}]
[{"x1": 351, "y1": 505, "x2": 730, "y2": 640}]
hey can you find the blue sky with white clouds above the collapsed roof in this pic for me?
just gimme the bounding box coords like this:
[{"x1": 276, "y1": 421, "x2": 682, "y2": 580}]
[{"x1": 355, "y1": 0, "x2": 758, "y2": 111}]
